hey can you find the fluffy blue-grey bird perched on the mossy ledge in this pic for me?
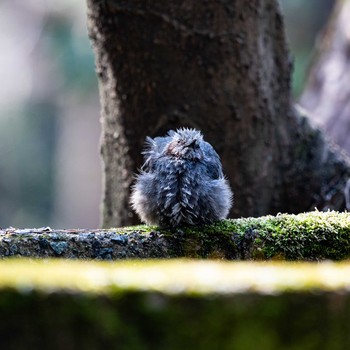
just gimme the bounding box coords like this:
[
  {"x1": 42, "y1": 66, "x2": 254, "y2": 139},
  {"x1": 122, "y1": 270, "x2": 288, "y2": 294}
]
[{"x1": 131, "y1": 128, "x2": 232, "y2": 227}]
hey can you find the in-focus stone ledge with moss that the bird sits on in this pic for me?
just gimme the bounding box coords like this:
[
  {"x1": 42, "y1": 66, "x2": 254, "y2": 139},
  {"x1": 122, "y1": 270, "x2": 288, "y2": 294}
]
[{"x1": 0, "y1": 211, "x2": 350, "y2": 261}]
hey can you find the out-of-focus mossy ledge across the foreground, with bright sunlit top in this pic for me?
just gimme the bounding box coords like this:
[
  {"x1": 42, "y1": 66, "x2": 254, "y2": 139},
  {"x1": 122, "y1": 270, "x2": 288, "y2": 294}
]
[{"x1": 0, "y1": 260, "x2": 350, "y2": 350}]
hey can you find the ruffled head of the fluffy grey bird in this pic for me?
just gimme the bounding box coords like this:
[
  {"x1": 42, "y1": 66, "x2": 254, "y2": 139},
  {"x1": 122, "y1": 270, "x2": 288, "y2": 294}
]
[{"x1": 165, "y1": 128, "x2": 203, "y2": 161}]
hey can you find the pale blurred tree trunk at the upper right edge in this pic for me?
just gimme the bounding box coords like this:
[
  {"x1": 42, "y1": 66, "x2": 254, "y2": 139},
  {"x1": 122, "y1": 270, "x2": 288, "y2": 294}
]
[{"x1": 300, "y1": 0, "x2": 350, "y2": 154}]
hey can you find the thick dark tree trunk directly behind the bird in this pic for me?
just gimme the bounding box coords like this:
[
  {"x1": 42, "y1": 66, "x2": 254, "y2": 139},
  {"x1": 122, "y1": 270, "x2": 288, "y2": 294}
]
[{"x1": 87, "y1": 0, "x2": 350, "y2": 227}]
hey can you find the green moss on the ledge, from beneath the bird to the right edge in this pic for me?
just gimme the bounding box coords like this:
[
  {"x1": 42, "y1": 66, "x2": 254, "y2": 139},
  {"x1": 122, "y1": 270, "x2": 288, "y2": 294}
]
[{"x1": 109, "y1": 211, "x2": 350, "y2": 260}]
